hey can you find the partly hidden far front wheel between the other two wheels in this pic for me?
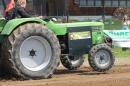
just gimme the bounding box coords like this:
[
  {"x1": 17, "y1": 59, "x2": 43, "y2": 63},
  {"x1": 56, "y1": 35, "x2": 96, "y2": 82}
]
[{"x1": 61, "y1": 55, "x2": 84, "y2": 70}]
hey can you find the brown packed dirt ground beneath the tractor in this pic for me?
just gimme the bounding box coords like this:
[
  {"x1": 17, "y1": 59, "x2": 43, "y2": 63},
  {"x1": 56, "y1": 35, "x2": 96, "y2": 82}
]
[{"x1": 0, "y1": 58, "x2": 130, "y2": 86}]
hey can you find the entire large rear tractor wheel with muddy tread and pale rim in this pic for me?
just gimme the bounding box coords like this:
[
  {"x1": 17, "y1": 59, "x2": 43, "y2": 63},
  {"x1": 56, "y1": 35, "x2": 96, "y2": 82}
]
[{"x1": 2, "y1": 23, "x2": 61, "y2": 79}]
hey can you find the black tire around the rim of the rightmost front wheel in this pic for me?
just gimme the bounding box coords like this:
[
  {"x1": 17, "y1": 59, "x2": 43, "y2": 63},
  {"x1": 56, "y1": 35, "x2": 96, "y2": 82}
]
[{"x1": 88, "y1": 44, "x2": 115, "y2": 72}]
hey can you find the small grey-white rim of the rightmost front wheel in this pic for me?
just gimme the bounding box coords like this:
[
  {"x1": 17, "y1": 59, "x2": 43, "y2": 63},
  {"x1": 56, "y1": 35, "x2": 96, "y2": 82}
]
[{"x1": 95, "y1": 50, "x2": 110, "y2": 67}]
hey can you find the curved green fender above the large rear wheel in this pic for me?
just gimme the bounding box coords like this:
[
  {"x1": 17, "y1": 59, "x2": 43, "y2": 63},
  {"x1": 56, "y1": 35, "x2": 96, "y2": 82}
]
[{"x1": 1, "y1": 18, "x2": 46, "y2": 35}]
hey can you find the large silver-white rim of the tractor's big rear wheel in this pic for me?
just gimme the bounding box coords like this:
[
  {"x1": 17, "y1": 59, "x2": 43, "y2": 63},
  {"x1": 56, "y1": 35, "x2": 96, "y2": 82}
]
[{"x1": 20, "y1": 36, "x2": 52, "y2": 71}]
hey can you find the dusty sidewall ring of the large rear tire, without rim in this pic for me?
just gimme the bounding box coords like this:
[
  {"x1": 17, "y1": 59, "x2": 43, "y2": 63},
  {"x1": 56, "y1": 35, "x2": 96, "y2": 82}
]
[{"x1": 12, "y1": 25, "x2": 58, "y2": 78}]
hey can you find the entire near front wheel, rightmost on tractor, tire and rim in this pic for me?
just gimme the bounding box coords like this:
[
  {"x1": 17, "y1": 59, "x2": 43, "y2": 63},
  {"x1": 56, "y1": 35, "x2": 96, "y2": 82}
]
[{"x1": 88, "y1": 44, "x2": 115, "y2": 72}]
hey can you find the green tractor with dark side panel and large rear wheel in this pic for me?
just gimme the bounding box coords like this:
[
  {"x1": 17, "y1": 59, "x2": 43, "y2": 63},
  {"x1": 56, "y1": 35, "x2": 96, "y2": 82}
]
[{"x1": 0, "y1": 0, "x2": 115, "y2": 79}]
